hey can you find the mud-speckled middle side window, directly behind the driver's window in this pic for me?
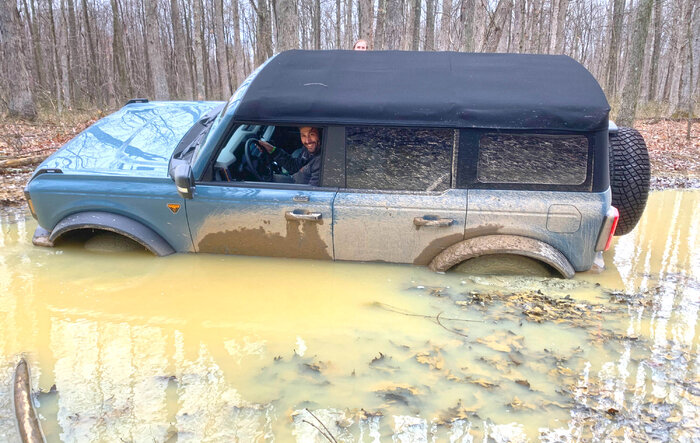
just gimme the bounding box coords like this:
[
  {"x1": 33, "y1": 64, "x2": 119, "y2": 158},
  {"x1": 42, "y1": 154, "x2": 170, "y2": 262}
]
[{"x1": 345, "y1": 127, "x2": 455, "y2": 191}]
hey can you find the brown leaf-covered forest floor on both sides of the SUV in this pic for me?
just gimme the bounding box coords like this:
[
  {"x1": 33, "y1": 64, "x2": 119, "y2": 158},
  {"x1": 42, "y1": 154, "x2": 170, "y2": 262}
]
[{"x1": 0, "y1": 112, "x2": 700, "y2": 207}]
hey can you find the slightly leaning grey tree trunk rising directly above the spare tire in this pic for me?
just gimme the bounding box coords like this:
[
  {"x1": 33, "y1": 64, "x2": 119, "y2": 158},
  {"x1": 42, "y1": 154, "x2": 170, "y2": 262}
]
[{"x1": 617, "y1": 0, "x2": 652, "y2": 126}]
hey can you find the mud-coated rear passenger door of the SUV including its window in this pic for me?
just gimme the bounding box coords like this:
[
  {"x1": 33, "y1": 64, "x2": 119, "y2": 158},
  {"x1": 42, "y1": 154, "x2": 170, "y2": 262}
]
[{"x1": 333, "y1": 127, "x2": 467, "y2": 265}]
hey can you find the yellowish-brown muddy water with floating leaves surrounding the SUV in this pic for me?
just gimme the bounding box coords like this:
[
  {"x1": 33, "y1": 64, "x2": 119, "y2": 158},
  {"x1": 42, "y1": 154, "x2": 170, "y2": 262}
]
[{"x1": 0, "y1": 191, "x2": 700, "y2": 442}]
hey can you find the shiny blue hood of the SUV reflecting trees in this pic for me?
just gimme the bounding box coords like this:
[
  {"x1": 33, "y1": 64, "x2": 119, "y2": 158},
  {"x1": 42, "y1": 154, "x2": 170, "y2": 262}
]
[{"x1": 38, "y1": 102, "x2": 222, "y2": 177}]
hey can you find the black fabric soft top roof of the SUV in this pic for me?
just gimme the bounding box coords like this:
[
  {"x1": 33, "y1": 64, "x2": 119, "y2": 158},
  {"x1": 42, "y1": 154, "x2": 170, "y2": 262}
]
[{"x1": 233, "y1": 50, "x2": 610, "y2": 131}]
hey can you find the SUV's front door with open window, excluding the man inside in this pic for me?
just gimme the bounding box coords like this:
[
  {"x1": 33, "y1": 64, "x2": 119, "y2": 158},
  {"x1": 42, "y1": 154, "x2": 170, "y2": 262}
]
[{"x1": 186, "y1": 125, "x2": 337, "y2": 260}]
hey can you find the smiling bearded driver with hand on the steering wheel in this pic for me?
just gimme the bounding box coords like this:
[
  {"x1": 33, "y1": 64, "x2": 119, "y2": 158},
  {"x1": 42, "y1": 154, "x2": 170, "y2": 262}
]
[{"x1": 257, "y1": 126, "x2": 321, "y2": 186}]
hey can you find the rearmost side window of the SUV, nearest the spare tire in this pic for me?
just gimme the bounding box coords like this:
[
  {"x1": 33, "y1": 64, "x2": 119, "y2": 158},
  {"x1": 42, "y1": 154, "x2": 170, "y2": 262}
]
[{"x1": 476, "y1": 133, "x2": 588, "y2": 185}]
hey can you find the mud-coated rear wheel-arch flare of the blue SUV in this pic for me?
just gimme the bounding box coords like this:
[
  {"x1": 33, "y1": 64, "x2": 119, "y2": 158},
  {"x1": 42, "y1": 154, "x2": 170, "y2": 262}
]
[{"x1": 428, "y1": 235, "x2": 576, "y2": 278}]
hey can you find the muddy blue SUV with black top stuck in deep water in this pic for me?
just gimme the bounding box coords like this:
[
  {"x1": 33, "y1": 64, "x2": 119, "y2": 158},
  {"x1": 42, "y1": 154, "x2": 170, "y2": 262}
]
[{"x1": 25, "y1": 51, "x2": 649, "y2": 277}]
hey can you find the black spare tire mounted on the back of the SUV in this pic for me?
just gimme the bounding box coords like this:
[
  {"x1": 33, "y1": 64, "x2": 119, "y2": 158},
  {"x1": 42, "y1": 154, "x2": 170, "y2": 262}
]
[{"x1": 610, "y1": 127, "x2": 650, "y2": 235}]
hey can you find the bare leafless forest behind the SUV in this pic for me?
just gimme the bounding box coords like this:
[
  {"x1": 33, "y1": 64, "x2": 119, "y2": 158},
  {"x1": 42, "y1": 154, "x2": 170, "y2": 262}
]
[{"x1": 0, "y1": 0, "x2": 700, "y2": 125}]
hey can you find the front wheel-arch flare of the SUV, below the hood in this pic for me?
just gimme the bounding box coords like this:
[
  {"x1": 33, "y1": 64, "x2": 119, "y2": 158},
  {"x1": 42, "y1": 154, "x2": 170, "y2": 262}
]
[{"x1": 49, "y1": 211, "x2": 175, "y2": 257}]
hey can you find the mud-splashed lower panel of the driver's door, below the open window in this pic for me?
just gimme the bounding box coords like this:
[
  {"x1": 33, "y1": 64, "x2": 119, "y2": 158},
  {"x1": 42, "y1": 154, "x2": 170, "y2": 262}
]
[{"x1": 187, "y1": 183, "x2": 335, "y2": 260}]
